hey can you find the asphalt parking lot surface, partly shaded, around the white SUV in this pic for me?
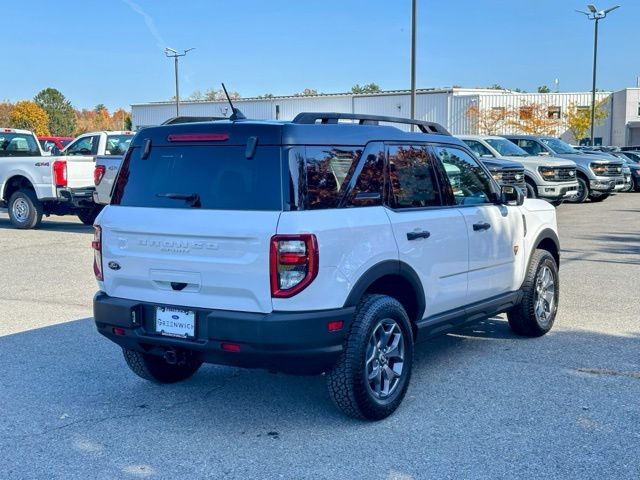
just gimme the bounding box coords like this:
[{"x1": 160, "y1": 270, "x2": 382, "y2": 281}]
[{"x1": 0, "y1": 194, "x2": 640, "y2": 479}]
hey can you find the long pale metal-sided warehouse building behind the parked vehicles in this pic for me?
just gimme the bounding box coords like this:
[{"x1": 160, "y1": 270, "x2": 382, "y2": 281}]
[{"x1": 131, "y1": 88, "x2": 640, "y2": 146}]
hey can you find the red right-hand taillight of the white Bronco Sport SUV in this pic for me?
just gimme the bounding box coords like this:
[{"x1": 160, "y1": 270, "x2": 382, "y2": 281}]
[{"x1": 270, "y1": 234, "x2": 318, "y2": 298}]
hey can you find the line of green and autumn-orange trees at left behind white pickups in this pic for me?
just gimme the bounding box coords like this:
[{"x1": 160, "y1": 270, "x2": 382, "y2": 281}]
[{"x1": 0, "y1": 88, "x2": 131, "y2": 137}]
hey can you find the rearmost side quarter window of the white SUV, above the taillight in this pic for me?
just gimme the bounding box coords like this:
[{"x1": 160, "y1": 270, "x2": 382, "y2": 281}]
[{"x1": 305, "y1": 147, "x2": 362, "y2": 210}]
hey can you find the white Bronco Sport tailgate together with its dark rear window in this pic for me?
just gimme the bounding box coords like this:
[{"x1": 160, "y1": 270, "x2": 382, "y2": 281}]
[{"x1": 99, "y1": 125, "x2": 283, "y2": 313}]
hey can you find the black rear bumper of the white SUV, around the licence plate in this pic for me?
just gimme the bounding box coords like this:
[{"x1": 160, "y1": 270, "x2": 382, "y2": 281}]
[{"x1": 93, "y1": 292, "x2": 355, "y2": 374}]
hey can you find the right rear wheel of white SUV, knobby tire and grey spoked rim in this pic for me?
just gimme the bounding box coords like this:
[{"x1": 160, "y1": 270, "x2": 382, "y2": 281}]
[{"x1": 327, "y1": 295, "x2": 413, "y2": 420}]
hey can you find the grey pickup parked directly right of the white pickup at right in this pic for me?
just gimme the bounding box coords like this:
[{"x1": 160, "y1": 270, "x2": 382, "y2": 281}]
[{"x1": 505, "y1": 135, "x2": 625, "y2": 203}]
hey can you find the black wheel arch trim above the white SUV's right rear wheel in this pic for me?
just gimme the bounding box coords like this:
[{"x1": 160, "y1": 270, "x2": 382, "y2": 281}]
[{"x1": 344, "y1": 260, "x2": 426, "y2": 320}]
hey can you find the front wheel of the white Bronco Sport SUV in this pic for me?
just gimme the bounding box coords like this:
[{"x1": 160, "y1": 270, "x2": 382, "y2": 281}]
[{"x1": 507, "y1": 250, "x2": 560, "y2": 337}]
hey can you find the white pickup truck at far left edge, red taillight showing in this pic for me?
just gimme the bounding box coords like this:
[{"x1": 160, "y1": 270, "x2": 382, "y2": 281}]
[{"x1": 0, "y1": 128, "x2": 99, "y2": 229}]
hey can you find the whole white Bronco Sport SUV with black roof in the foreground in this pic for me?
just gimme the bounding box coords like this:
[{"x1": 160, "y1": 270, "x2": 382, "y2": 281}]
[{"x1": 93, "y1": 113, "x2": 559, "y2": 419}]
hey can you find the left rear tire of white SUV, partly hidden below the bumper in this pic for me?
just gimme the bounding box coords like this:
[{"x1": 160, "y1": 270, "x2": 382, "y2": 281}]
[{"x1": 122, "y1": 348, "x2": 202, "y2": 383}]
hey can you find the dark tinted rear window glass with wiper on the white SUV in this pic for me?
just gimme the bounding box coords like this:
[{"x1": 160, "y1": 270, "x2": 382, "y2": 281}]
[{"x1": 111, "y1": 146, "x2": 282, "y2": 210}]
